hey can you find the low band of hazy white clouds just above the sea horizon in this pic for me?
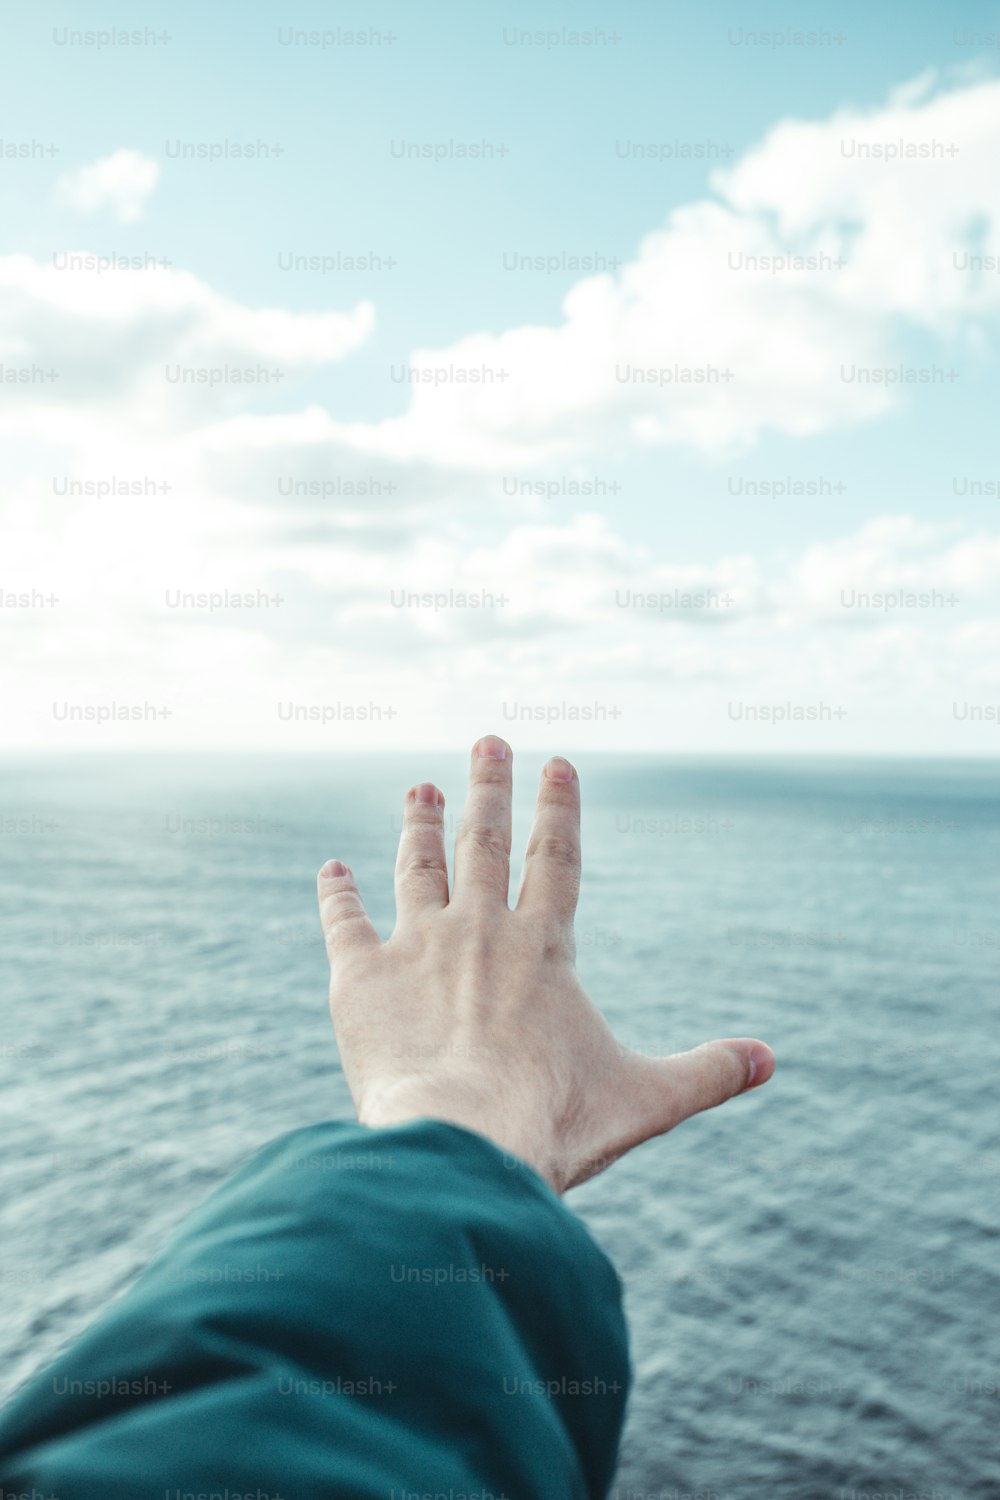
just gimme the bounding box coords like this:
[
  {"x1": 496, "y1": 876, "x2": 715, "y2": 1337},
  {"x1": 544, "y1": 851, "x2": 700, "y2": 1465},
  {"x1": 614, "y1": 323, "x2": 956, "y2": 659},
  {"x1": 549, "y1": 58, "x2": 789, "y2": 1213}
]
[{"x1": 0, "y1": 494, "x2": 1000, "y2": 752}]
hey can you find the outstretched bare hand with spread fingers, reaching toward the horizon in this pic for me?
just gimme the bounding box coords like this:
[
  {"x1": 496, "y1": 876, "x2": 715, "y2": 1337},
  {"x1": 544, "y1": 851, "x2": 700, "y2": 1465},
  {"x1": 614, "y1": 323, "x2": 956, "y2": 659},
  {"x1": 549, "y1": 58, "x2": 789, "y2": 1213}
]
[{"x1": 318, "y1": 735, "x2": 774, "y2": 1193}]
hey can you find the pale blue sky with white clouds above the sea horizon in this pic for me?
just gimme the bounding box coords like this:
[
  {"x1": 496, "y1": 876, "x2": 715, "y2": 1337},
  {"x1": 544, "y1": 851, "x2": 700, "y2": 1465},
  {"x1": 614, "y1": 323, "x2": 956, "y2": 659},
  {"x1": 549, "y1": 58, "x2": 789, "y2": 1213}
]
[{"x1": 0, "y1": 0, "x2": 1000, "y2": 756}]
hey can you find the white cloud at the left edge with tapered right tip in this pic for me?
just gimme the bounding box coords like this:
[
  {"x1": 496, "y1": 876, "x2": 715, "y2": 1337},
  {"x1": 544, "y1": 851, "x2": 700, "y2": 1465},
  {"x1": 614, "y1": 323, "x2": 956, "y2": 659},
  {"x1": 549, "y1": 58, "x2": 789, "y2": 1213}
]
[{"x1": 0, "y1": 251, "x2": 375, "y2": 443}]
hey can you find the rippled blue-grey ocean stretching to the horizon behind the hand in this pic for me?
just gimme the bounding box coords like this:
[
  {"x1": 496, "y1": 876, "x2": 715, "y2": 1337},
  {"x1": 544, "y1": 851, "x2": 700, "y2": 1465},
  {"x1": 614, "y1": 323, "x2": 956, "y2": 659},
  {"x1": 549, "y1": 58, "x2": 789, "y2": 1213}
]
[{"x1": 0, "y1": 746, "x2": 1000, "y2": 1500}]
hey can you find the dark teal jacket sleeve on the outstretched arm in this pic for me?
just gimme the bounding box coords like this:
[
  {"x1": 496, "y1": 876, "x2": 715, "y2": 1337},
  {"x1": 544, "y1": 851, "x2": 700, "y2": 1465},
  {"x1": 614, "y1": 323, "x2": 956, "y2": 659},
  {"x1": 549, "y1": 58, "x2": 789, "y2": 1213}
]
[{"x1": 0, "y1": 1119, "x2": 630, "y2": 1500}]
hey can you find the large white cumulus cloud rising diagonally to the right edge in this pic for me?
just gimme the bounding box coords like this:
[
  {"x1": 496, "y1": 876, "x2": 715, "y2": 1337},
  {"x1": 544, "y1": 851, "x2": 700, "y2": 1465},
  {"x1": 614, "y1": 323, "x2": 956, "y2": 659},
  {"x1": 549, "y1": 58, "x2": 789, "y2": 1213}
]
[{"x1": 341, "y1": 70, "x2": 1000, "y2": 467}]
